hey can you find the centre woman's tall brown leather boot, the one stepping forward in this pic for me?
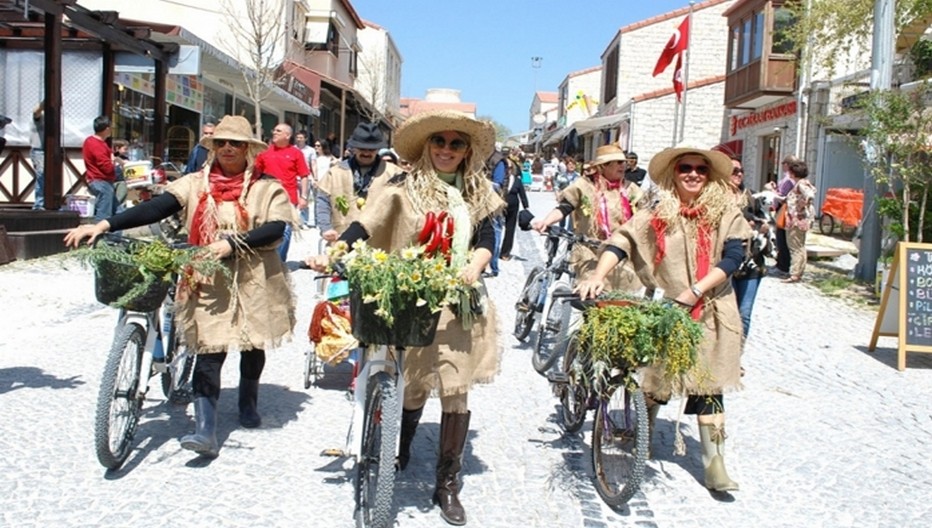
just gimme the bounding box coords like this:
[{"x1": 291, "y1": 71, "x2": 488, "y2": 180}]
[{"x1": 433, "y1": 413, "x2": 471, "y2": 526}]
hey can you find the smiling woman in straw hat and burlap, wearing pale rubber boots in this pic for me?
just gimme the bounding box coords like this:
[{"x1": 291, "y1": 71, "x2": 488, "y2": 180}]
[{"x1": 577, "y1": 143, "x2": 751, "y2": 491}]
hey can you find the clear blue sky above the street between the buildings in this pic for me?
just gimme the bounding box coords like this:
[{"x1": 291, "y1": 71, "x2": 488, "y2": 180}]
[{"x1": 352, "y1": 0, "x2": 689, "y2": 134}]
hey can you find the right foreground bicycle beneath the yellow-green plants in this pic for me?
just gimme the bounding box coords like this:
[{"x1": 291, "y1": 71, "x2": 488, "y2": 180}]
[{"x1": 548, "y1": 293, "x2": 650, "y2": 508}]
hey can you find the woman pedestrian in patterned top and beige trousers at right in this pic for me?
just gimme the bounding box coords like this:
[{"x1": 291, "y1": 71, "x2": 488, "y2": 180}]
[{"x1": 783, "y1": 160, "x2": 816, "y2": 282}]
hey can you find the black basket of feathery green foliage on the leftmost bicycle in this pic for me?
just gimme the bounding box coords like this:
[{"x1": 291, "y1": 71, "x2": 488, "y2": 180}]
[{"x1": 72, "y1": 238, "x2": 231, "y2": 309}]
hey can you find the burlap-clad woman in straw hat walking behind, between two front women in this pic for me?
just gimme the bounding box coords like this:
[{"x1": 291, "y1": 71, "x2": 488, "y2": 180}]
[{"x1": 531, "y1": 145, "x2": 641, "y2": 291}]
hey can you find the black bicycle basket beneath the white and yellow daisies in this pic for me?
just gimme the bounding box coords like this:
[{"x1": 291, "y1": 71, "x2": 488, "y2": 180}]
[{"x1": 350, "y1": 286, "x2": 440, "y2": 347}]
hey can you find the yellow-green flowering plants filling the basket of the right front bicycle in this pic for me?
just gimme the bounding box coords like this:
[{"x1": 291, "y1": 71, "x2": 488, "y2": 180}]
[{"x1": 579, "y1": 295, "x2": 703, "y2": 394}]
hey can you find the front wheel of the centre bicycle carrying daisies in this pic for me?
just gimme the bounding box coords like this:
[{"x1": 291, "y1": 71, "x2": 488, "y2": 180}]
[{"x1": 356, "y1": 372, "x2": 400, "y2": 528}]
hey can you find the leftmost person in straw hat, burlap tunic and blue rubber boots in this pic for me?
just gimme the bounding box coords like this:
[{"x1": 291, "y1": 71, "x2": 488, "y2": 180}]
[{"x1": 65, "y1": 116, "x2": 296, "y2": 457}]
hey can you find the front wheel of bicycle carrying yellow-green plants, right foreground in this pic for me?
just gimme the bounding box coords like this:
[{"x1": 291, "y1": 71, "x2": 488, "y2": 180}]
[{"x1": 592, "y1": 387, "x2": 648, "y2": 508}]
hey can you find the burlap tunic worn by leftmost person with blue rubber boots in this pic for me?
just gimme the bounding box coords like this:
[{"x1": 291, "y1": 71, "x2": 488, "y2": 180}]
[{"x1": 166, "y1": 174, "x2": 295, "y2": 353}]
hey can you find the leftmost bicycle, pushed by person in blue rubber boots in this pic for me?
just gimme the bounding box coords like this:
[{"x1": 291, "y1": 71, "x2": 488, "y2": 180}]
[{"x1": 94, "y1": 235, "x2": 194, "y2": 469}]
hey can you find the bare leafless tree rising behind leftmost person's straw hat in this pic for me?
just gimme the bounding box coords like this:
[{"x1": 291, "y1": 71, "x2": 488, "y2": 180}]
[{"x1": 218, "y1": 0, "x2": 286, "y2": 138}]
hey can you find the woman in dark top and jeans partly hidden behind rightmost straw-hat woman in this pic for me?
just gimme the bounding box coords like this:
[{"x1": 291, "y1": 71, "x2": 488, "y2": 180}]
[{"x1": 729, "y1": 157, "x2": 770, "y2": 339}]
